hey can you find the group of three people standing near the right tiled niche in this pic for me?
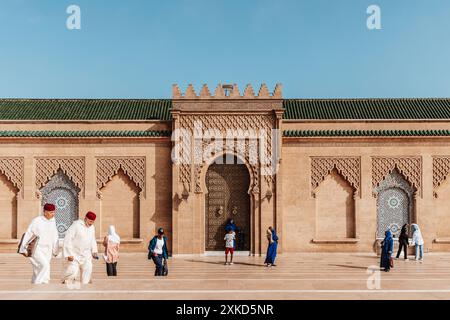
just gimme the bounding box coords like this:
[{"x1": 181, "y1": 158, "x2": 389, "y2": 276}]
[{"x1": 380, "y1": 223, "x2": 424, "y2": 272}]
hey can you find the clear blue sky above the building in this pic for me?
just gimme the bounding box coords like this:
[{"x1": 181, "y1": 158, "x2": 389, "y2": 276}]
[{"x1": 0, "y1": 0, "x2": 450, "y2": 98}]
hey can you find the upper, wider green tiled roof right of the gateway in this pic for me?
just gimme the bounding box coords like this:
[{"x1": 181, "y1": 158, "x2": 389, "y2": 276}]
[{"x1": 283, "y1": 98, "x2": 450, "y2": 120}]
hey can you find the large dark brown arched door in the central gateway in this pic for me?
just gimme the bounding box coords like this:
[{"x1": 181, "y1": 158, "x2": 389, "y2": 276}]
[{"x1": 205, "y1": 157, "x2": 250, "y2": 251}]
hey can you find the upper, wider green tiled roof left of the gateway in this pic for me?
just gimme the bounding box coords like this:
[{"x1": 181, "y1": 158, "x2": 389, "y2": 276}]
[{"x1": 0, "y1": 99, "x2": 172, "y2": 120}]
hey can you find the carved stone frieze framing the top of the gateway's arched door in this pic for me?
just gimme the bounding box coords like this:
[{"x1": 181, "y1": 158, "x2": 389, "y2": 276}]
[{"x1": 178, "y1": 114, "x2": 276, "y2": 193}]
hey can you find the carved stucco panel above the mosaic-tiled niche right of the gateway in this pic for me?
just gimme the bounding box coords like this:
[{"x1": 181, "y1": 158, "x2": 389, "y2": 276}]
[{"x1": 372, "y1": 156, "x2": 422, "y2": 197}]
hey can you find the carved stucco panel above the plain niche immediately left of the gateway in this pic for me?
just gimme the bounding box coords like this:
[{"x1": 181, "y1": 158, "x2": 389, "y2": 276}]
[{"x1": 97, "y1": 157, "x2": 145, "y2": 198}]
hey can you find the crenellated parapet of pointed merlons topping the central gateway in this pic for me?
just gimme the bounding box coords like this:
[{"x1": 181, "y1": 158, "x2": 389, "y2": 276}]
[{"x1": 172, "y1": 83, "x2": 283, "y2": 99}]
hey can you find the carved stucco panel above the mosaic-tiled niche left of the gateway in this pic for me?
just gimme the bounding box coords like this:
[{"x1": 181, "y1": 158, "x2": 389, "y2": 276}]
[{"x1": 36, "y1": 157, "x2": 85, "y2": 197}]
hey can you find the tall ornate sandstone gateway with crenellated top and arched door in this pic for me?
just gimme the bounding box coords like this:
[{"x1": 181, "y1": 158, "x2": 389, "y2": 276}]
[{"x1": 171, "y1": 84, "x2": 284, "y2": 254}]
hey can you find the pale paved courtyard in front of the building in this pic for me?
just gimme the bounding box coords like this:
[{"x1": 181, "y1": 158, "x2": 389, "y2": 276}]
[{"x1": 0, "y1": 253, "x2": 450, "y2": 299}]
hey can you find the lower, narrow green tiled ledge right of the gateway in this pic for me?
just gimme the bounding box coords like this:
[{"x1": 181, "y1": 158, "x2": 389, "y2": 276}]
[{"x1": 283, "y1": 130, "x2": 450, "y2": 138}]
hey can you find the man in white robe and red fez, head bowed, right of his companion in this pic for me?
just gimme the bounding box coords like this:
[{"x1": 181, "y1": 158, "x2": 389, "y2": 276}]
[{"x1": 64, "y1": 211, "x2": 98, "y2": 284}]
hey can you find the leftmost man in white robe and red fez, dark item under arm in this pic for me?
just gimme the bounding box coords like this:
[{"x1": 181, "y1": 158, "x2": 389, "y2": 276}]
[{"x1": 19, "y1": 203, "x2": 59, "y2": 284}]
